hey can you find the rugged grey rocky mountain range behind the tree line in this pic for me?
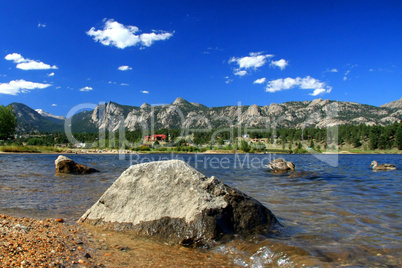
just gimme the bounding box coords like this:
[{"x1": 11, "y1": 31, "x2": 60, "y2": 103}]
[{"x1": 10, "y1": 97, "x2": 402, "y2": 132}]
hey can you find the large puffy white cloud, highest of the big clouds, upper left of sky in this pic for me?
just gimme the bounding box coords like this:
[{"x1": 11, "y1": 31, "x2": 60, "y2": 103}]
[{"x1": 87, "y1": 19, "x2": 173, "y2": 49}]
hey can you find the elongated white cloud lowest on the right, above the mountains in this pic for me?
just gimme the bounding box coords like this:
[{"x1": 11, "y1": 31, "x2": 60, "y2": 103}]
[{"x1": 265, "y1": 76, "x2": 332, "y2": 96}]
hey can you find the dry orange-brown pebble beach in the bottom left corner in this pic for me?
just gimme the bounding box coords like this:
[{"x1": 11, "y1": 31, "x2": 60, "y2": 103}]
[{"x1": 0, "y1": 214, "x2": 103, "y2": 267}]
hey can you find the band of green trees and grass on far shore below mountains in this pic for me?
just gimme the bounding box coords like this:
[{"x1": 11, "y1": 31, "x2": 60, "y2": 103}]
[{"x1": 0, "y1": 122, "x2": 402, "y2": 154}]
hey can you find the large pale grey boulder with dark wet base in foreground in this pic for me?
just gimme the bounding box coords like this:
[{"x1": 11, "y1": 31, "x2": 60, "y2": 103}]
[{"x1": 80, "y1": 160, "x2": 278, "y2": 246}]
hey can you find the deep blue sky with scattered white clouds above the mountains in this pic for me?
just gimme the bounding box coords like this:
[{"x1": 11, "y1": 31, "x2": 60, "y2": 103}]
[{"x1": 0, "y1": 0, "x2": 402, "y2": 115}]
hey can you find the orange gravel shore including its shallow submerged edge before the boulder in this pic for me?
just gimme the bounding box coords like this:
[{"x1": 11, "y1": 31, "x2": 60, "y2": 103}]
[{"x1": 0, "y1": 213, "x2": 236, "y2": 267}]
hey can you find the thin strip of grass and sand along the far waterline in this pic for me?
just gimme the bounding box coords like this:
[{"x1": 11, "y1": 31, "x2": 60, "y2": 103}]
[{"x1": 0, "y1": 145, "x2": 402, "y2": 154}]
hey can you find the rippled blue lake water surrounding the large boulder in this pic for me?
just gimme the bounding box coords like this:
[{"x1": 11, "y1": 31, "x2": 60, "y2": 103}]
[{"x1": 0, "y1": 154, "x2": 402, "y2": 267}]
